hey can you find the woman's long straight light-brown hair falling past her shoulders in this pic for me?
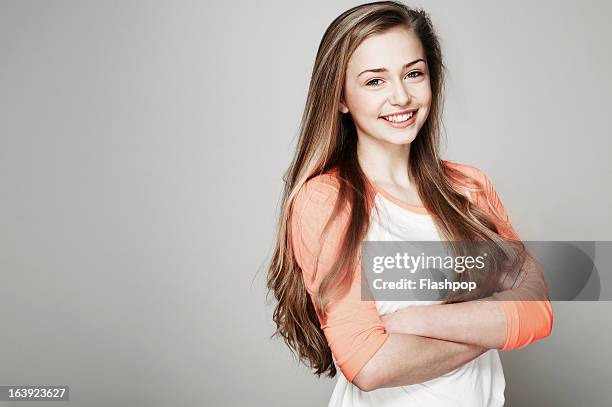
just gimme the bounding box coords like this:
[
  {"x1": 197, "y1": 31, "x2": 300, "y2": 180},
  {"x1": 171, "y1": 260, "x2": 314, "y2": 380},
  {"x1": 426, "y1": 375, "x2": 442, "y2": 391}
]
[{"x1": 267, "y1": 1, "x2": 518, "y2": 377}]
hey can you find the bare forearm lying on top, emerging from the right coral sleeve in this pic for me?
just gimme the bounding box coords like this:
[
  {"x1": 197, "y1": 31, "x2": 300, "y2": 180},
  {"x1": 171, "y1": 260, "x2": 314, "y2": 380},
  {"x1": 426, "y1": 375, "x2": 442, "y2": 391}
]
[{"x1": 383, "y1": 301, "x2": 507, "y2": 349}]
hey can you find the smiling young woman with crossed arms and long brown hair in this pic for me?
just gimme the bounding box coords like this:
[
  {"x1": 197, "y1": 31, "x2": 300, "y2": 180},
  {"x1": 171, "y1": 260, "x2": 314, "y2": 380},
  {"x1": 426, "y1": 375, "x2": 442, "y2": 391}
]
[{"x1": 268, "y1": 1, "x2": 553, "y2": 407}]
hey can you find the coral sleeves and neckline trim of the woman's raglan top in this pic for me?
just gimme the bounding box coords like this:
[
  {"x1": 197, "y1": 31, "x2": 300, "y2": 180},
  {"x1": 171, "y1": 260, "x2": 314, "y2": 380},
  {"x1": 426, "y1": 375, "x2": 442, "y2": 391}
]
[{"x1": 291, "y1": 160, "x2": 553, "y2": 383}]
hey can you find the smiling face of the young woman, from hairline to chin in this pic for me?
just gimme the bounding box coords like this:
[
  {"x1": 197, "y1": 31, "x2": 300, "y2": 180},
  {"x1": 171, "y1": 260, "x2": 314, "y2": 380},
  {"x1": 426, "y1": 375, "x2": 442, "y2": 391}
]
[{"x1": 340, "y1": 27, "x2": 432, "y2": 145}]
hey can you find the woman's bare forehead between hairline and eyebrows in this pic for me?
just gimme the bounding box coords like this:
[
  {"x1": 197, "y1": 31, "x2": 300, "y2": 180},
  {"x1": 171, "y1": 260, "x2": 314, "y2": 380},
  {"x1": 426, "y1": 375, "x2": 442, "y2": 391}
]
[{"x1": 347, "y1": 27, "x2": 425, "y2": 73}]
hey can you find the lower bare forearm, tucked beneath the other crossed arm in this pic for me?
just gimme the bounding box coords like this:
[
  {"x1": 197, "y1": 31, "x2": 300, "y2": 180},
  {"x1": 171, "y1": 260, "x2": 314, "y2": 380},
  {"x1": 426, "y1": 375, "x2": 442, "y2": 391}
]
[{"x1": 354, "y1": 333, "x2": 488, "y2": 390}]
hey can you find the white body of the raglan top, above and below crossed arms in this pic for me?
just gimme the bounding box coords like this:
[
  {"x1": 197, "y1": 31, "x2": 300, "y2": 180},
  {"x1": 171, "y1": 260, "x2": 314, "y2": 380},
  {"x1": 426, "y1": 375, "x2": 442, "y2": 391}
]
[{"x1": 329, "y1": 193, "x2": 506, "y2": 407}]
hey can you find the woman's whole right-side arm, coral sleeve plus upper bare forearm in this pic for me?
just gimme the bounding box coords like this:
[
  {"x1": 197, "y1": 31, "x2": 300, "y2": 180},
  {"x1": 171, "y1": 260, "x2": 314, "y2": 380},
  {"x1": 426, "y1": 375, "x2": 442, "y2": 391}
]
[{"x1": 383, "y1": 168, "x2": 553, "y2": 350}]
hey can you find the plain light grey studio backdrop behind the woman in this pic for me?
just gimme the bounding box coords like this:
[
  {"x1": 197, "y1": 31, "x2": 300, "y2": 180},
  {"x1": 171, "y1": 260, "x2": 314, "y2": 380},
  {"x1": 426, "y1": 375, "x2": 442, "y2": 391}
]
[{"x1": 0, "y1": 0, "x2": 612, "y2": 406}]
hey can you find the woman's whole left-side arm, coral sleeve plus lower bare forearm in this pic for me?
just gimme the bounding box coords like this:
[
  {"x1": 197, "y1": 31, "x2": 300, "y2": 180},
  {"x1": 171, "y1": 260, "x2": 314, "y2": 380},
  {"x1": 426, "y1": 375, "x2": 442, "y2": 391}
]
[{"x1": 291, "y1": 176, "x2": 487, "y2": 391}]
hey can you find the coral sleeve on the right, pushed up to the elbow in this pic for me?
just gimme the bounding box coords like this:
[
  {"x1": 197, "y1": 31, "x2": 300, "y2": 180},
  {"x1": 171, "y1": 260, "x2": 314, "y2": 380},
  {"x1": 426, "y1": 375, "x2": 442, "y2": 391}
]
[{"x1": 478, "y1": 166, "x2": 554, "y2": 350}]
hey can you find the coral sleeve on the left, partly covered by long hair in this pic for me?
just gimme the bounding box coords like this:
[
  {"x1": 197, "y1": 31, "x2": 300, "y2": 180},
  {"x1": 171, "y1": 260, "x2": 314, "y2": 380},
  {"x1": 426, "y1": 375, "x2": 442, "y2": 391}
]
[{"x1": 291, "y1": 174, "x2": 389, "y2": 383}]
